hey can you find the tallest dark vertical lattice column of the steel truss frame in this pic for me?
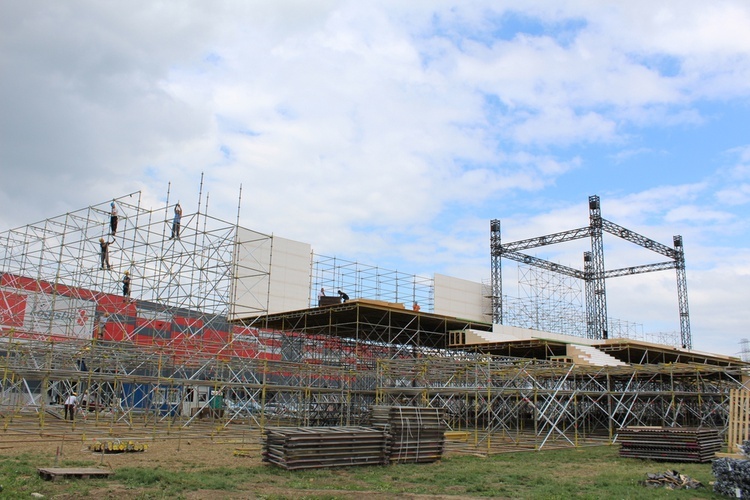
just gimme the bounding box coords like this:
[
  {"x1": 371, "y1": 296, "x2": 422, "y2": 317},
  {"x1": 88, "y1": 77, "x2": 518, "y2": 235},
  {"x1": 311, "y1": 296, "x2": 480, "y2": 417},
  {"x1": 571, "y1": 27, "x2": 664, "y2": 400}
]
[{"x1": 586, "y1": 195, "x2": 608, "y2": 339}]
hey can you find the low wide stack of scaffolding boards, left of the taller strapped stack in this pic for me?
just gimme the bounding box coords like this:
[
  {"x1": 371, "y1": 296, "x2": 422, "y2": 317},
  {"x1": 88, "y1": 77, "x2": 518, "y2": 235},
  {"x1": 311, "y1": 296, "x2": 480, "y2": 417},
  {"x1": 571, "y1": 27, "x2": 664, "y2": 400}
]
[{"x1": 263, "y1": 427, "x2": 389, "y2": 470}]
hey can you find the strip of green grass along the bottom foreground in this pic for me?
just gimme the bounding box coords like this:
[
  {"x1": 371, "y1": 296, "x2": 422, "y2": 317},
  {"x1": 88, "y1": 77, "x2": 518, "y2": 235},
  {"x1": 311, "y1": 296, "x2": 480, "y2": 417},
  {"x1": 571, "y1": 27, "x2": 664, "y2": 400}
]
[{"x1": 0, "y1": 446, "x2": 721, "y2": 499}]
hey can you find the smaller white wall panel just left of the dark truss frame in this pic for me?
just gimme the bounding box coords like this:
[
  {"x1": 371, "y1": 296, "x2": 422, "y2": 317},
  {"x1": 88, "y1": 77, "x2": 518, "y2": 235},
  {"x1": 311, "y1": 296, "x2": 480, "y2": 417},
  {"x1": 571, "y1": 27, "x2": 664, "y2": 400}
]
[{"x1": 434, "y1": 274, "x2": 492, "y2": 322}]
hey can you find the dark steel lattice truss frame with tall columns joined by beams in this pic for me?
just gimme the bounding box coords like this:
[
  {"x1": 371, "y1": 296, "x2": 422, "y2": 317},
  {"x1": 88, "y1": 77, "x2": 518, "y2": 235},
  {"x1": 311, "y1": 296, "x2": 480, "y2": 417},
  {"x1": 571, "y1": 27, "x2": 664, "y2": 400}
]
[{"x1": 490, "y1": 195, "x2": 693, "y2": 349}]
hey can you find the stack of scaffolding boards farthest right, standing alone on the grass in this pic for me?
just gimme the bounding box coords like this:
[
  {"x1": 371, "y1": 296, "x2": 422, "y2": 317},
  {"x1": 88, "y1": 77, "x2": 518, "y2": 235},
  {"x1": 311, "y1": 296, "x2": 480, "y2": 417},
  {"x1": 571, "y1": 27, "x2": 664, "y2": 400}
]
[{"x1": 619, "y1": 427, "x2": 723, "y2": 463}]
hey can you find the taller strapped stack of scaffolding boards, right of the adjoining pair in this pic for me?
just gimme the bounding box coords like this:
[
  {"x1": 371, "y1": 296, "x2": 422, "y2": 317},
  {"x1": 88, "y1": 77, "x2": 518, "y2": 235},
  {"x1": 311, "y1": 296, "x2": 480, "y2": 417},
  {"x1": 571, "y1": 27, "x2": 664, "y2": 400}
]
[{"x1": 370, "y1": 406, "x2": 446, "y2": 463}]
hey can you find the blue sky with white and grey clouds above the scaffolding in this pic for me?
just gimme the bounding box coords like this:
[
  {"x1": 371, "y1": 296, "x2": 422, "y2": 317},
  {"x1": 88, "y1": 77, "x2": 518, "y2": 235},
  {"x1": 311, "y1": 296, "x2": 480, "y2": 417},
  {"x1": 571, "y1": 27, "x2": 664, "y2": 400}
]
[{"x1": 0, "y1": 0, "x2": 750, "y2": 355}]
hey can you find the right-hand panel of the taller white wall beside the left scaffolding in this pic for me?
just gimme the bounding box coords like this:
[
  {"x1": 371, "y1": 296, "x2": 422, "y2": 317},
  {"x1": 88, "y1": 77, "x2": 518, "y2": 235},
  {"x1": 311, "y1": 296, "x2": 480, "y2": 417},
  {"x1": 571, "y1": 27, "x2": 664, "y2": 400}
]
[{"x1": 268, "y1": 236, "x2": 312, "y2": 313}]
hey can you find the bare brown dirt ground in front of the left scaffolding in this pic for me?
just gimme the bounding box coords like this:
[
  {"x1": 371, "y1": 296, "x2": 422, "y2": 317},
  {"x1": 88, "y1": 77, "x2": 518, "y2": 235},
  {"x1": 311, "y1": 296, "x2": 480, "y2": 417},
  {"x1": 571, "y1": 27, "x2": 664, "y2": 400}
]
[{"x1": 0, "y1": 422, "x2": 468, "y2": 500}]
